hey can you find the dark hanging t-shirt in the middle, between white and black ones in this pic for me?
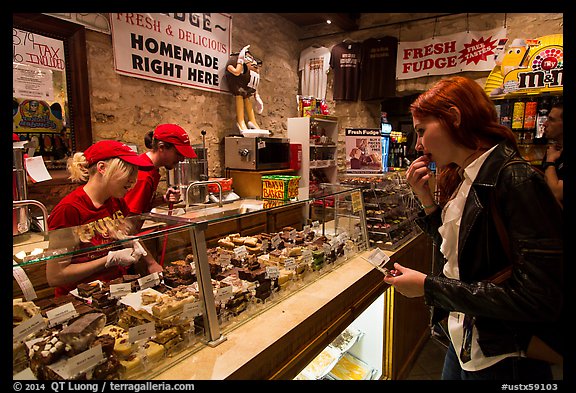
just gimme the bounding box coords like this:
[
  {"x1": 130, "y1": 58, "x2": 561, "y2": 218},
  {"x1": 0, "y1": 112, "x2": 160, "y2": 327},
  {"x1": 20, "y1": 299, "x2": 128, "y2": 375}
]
[{"x1": 330, "y1": 41, "x2": 362, "y2": 101}]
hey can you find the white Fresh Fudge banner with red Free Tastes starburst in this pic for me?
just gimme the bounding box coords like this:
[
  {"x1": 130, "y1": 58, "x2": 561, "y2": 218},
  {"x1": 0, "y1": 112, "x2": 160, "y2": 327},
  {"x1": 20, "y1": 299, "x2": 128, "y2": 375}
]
[{"x1": 396, "y1": 28, "x2": 506, "y2": 80}]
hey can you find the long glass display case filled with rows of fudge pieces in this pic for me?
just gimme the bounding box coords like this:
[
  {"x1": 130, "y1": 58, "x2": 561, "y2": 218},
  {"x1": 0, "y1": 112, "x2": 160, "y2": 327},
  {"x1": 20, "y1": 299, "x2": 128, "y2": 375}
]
[{"x1": 13, "y1": 185, "x2": 368, "y2": 379}]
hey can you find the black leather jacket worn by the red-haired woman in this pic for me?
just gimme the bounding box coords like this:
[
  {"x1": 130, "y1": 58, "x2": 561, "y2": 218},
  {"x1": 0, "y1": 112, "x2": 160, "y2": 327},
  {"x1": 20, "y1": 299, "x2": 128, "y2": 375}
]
[{"x1": 416, "y1": 142, "x2": 563, "y2": 356}]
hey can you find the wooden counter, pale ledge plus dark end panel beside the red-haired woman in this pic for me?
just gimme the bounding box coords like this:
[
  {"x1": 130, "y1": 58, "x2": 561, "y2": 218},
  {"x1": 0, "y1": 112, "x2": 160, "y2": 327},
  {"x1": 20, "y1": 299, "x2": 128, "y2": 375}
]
[{"x1": 155, "y1": 231, "x2": 432, "y2": 380}]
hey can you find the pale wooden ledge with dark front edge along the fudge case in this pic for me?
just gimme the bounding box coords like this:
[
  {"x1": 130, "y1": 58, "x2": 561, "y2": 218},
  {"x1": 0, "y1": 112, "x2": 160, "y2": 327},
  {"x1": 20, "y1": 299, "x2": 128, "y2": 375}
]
[{"x1": 155, "y1": 251, "x2": 386, "y2": 380}]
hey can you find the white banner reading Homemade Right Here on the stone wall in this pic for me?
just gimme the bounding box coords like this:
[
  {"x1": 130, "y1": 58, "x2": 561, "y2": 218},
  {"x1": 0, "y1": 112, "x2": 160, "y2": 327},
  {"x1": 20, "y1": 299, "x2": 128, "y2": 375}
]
[{"x1": 110, "y1": 13, "x2": 232, "y2": 93}]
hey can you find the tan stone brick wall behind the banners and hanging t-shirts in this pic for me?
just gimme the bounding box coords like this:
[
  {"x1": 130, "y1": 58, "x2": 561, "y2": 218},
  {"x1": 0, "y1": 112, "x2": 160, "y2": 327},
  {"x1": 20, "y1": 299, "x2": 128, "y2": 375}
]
[{"x1": 86, "y1": 13, "x2": 563, "y2": 192}]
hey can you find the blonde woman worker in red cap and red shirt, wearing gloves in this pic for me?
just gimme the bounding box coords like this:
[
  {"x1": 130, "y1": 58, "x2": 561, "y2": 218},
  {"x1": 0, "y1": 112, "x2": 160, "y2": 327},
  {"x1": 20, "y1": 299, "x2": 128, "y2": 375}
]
[{"x1": 46, "y1": 141, "x2": 162, "y2": 296}]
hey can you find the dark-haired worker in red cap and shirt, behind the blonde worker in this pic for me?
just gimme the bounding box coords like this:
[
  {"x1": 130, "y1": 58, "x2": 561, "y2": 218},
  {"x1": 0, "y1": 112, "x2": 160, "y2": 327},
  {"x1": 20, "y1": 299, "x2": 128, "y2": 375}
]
[{"x1": 124, "y1": 124, "x2": 197, "y2": 214}]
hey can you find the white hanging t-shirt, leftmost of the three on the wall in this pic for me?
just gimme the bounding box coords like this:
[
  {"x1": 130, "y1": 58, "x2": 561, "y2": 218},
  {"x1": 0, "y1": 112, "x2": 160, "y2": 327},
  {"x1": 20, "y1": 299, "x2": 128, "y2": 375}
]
[{"x1": 298, "y1": 46, "x2": 330, "y2": 100}]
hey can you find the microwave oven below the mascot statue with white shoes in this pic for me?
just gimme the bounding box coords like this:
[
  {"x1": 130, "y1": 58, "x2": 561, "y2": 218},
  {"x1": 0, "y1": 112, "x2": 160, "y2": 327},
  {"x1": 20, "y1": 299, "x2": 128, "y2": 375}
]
[{"x1": 224, "y1": 136, "x2": 290, "y2": 171}]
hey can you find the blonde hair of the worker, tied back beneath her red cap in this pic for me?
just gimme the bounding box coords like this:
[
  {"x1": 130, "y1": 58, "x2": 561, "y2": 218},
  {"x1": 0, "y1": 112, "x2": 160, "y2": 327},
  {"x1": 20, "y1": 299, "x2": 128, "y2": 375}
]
[{"x1": 66, "y1": 152, "x2": 138, "y2": 183}]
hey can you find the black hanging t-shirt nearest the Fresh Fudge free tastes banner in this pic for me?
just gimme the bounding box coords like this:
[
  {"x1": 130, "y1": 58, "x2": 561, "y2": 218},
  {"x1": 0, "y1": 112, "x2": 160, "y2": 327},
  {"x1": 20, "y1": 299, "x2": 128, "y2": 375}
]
[{"x1": 360, "y1": 36, "x2": 398, "y2": 101}]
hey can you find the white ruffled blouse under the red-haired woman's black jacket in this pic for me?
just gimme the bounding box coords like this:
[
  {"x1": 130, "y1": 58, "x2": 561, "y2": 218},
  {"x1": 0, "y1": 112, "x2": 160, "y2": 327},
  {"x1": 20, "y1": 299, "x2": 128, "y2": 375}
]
[{"x1": 438, "y1": 146, "x2": 519, "y2": 371}]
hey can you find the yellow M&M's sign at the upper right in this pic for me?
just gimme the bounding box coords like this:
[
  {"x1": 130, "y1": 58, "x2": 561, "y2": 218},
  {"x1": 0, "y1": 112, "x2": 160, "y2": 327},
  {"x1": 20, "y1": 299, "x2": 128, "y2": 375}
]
[{"x1": 484, "y1": 34, "x2": 564, "y2": 98}]
